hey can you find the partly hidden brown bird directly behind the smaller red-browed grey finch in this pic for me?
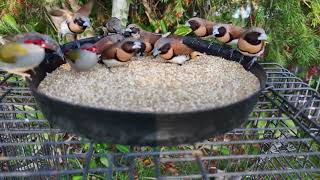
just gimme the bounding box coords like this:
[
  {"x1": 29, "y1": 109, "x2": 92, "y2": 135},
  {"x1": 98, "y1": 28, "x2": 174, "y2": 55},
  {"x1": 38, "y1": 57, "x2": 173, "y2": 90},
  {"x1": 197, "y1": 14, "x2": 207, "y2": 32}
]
[{"x1": 94, "y1": 34, "x2": 125, "y2": 54}]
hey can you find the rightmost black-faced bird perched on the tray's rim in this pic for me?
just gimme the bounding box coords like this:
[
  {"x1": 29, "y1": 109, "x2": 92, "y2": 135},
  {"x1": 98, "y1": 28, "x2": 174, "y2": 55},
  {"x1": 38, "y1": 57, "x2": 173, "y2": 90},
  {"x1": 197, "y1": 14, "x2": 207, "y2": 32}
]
[{"x1": 237, "y1": 27, "x2": 268, "y2": 67}]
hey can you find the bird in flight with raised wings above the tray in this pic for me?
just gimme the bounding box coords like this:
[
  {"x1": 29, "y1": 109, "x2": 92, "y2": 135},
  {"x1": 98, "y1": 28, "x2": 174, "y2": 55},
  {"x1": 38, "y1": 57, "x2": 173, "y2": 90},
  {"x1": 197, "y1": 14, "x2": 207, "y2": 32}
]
[{"x1": 49, "y1": 0, "x2": 95, "y2": 39}]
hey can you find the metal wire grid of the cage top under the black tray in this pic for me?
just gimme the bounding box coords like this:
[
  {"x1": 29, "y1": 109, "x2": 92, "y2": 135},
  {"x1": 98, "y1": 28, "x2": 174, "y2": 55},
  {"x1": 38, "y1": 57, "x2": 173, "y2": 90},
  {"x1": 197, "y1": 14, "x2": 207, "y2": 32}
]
[{"x1": 0, "y1": 63, "x2": 320, "y2": 179}]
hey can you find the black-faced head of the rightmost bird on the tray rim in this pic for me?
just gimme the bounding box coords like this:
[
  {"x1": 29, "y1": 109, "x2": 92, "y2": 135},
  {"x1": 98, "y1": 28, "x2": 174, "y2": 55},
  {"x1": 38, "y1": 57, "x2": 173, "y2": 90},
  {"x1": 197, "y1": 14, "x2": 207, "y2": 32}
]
[{"x1": 243, "y1": 27, "x2": 268, "y2": 45}]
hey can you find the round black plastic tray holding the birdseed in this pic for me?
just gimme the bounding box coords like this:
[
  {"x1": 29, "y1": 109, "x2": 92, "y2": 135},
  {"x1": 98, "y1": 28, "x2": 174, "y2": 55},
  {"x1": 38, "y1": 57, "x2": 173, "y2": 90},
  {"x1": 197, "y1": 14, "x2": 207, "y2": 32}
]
[{"x1": 29, "y1": 37, "x2": 266, "y2": 146}]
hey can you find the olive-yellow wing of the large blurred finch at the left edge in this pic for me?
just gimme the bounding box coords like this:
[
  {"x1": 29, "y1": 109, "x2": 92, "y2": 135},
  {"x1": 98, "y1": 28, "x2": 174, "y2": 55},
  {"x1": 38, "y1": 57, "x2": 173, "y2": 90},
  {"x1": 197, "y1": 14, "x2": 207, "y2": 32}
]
[{"x1": 0, "y1": 43, "x2": 28, "y2": 64}]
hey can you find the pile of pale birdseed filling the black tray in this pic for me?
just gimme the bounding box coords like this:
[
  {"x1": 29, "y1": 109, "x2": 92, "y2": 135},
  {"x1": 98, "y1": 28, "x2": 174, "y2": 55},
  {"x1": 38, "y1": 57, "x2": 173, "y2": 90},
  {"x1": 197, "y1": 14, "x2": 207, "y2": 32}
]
[{"x1": 39, "y1": 55, "x2": 260, "y2": 112}]
